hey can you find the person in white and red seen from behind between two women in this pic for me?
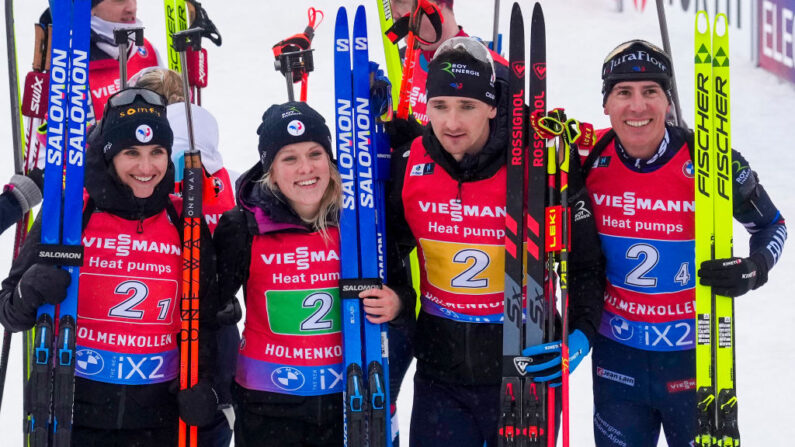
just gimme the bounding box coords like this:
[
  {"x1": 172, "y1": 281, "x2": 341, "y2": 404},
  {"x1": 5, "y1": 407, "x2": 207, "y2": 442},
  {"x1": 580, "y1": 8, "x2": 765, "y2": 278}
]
[{"x1": 130, "y1": 67, "x2": 235, "y2": 447}]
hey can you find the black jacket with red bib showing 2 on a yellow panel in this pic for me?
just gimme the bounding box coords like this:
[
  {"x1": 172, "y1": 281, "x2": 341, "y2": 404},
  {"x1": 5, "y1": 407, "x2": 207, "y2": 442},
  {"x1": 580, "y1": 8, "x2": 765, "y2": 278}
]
[{"x1": 387, "y1": 83, "x2": 604, "y2": 385}]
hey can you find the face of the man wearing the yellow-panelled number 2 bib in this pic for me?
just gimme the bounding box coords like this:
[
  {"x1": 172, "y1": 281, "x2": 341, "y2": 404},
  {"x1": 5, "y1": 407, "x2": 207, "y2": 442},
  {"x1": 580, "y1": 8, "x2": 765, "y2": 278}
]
[{"x1": 428, "y1": 96, "x2": 497, "y2": 161}]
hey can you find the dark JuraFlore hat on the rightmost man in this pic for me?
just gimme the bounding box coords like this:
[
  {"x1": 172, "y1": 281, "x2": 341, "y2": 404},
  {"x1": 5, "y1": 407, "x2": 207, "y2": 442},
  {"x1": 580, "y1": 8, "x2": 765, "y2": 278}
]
[{"x1": 602, "y1": 39, "x2": 673, "y2": 105}]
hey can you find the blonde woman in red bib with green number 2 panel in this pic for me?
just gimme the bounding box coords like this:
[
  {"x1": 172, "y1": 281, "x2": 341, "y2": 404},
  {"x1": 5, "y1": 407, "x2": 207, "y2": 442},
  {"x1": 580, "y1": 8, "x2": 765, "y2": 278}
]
[{"x1": 214, "y1": 102, "x2": 404, "y2": 447}]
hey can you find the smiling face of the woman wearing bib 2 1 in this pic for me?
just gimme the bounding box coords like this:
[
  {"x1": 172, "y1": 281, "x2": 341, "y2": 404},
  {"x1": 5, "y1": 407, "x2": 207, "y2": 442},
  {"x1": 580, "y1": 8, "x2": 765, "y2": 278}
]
[{"x1": 113, "y1": 144, "x2": 169, "y2": 199}]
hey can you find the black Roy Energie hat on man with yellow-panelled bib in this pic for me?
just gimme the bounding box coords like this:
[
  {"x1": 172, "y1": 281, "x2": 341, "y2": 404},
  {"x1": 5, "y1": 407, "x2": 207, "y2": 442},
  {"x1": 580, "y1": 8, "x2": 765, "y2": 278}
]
[{"x1": 425, "y1": 44, "x2": 497, "y2": 106}]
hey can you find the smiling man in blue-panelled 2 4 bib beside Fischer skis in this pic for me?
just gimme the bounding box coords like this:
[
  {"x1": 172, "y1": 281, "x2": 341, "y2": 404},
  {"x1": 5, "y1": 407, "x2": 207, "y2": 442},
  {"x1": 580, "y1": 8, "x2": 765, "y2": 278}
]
[{"x1": 544, "y1": 40, "x2": 786, "y2": 447}]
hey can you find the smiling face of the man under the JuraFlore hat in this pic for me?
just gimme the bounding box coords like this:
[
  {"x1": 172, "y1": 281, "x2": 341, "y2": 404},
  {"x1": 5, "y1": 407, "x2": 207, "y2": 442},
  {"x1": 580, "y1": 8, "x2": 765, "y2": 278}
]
[{"x1": 604, "y1": 81, "x2": 670, "y2": 160}]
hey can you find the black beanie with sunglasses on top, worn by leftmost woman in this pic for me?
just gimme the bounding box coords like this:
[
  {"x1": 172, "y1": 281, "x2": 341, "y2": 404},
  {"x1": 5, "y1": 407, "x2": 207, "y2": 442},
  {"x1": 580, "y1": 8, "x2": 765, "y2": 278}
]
[{"x1": 96, "y1": 90, "x2": 174, "y2": 162}]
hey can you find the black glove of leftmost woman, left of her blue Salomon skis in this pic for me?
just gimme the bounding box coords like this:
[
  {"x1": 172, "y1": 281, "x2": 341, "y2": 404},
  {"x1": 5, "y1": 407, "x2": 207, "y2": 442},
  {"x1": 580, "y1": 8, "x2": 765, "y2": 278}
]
[{"x1": 13, "y1": 264, "x2": 72, "y2": 312}]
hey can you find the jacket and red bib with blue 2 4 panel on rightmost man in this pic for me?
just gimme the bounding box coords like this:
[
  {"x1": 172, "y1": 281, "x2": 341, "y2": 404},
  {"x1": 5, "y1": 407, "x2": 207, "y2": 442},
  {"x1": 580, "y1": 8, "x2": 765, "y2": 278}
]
[{"x1": 586, "y1": 127, "x2": 786, "y2": 351}]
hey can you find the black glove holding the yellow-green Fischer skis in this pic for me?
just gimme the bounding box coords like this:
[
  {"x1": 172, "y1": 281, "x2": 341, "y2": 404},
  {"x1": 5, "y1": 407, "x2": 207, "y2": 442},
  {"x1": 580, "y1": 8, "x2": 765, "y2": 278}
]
[{"x1": 698, "y1": 254, "x2": 767, "y2": 297}]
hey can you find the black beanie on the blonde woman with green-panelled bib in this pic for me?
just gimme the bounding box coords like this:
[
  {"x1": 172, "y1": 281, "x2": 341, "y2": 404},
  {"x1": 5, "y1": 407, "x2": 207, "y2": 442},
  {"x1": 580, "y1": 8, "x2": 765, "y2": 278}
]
[{"x1": 257, "y1": 101, "x2": 334, "y2": 172}]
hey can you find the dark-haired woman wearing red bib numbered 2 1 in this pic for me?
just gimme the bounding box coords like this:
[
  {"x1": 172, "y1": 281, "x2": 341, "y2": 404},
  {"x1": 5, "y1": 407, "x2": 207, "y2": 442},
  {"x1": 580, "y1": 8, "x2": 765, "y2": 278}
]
[{"x1": 0, "y1": 89, "x2": 218, "y2": 445}]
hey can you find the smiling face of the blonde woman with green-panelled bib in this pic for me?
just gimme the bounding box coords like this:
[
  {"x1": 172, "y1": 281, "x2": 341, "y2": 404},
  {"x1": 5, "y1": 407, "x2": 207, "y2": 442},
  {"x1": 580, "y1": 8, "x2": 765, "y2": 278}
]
[{"x1": 271, "y1": 141, "x2": 331, "y2": 220}]
